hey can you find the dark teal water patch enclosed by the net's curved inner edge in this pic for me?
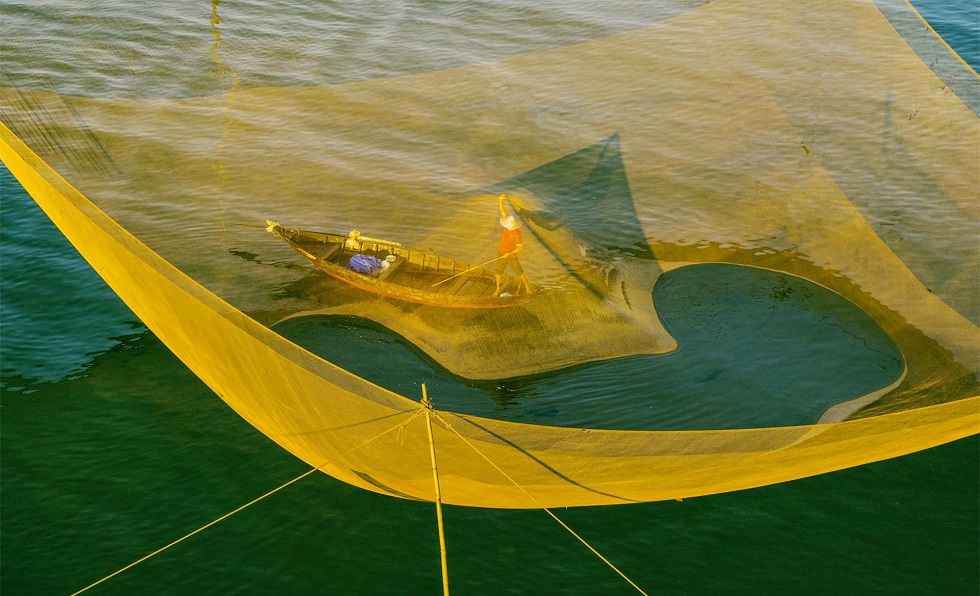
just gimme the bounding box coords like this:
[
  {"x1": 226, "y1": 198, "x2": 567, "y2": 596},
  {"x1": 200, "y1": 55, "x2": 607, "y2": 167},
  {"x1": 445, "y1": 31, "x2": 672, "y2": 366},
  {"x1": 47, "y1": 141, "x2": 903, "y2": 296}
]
[{"x1": 275, "y1": 264, "x2": 903, "y2": 430}]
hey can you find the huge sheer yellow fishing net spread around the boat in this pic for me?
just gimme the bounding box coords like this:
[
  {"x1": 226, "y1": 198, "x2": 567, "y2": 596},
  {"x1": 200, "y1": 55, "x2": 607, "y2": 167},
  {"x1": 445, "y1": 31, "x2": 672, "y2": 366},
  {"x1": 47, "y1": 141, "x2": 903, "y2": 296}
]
[{"x1": 0, "y1": 0, "x2": 980, "y2": 508}]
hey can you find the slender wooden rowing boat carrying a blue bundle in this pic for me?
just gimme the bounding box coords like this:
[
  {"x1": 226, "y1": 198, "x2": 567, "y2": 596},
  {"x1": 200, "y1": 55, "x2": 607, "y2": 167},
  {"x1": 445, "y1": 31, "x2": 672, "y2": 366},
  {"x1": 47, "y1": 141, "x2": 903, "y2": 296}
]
[{"x1": 266, "y1": 221, "x2": 534, "y2": 308}]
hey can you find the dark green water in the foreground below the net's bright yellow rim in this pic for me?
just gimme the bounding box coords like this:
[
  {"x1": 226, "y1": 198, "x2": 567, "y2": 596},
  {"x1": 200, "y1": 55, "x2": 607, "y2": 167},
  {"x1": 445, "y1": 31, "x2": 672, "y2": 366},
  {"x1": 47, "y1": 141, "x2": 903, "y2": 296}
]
[{"x1": 0, "y1": 328, "x2": 980, "y2": 595}]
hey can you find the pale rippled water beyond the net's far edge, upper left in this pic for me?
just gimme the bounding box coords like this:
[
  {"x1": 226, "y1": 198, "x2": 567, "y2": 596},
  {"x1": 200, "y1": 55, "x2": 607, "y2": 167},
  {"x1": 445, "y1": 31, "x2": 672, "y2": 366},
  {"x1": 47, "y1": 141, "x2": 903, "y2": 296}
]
[{"x1": 4, "y1": 0, "x2": 708, "y2": 98}]
